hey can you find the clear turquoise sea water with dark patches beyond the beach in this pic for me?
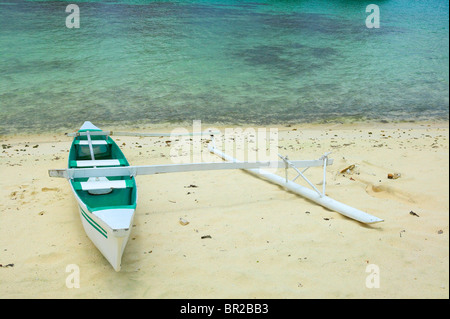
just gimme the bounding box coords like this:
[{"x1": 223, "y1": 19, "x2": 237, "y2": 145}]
[{"x1": 0, "y1": 0, "x2": 449, "y2": 134}]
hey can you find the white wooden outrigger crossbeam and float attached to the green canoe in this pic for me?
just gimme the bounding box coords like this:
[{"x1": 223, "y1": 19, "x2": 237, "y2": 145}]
[{"x1": 49, "y1": 131, "x2": 383, "y2": 224}]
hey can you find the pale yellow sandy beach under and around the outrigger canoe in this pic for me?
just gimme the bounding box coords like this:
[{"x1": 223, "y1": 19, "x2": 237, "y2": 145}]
[{"x1": 0, "y1": 122, "x2": 449, "y2": 299}]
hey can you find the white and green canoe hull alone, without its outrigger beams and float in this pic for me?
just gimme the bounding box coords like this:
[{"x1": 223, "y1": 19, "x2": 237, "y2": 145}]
[{"x1": 68, "y1": 122, "x2": 137, "y2": 271}]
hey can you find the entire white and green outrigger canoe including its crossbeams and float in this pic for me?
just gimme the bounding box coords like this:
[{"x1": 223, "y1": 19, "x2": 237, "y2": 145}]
[{"x1": 49, "y1": 121, "x2": 383, "y2": 271}]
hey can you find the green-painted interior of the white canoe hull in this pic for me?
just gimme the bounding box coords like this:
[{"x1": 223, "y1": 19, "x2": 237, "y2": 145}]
[{"x1": 69, "y1": 135, "x2": 136, "y2": 211}]
